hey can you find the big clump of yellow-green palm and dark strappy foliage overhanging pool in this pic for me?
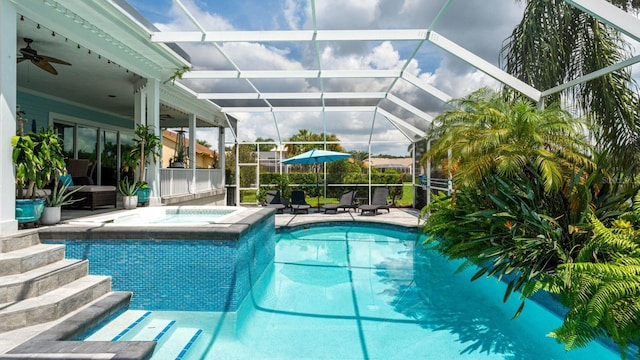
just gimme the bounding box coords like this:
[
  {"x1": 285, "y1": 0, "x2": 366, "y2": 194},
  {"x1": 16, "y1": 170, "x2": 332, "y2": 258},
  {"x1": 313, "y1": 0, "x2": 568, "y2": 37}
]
[{"x1": 423, "y1": 90, "x2": 639, "y2": 354}]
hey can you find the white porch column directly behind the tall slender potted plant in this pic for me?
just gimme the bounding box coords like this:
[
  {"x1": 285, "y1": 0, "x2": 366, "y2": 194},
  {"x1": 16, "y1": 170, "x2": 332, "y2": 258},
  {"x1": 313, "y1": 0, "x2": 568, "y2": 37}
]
[{"x1": 147, "y1": 79, "x2": 162, "y2": 206}]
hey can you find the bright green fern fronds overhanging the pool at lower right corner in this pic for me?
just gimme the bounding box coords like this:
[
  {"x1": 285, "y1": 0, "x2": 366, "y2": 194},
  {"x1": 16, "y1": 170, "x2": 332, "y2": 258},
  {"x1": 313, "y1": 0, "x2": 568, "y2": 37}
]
[{"x1": 551, "y1": 208, "x2": 640, "y2": 355}]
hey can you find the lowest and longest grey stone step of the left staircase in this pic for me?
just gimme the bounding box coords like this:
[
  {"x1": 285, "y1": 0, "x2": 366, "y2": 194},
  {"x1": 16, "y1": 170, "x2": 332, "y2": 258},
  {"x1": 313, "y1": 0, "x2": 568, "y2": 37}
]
[{"x1": 0, "y1": 275, "x2": 111, "y2": 332}]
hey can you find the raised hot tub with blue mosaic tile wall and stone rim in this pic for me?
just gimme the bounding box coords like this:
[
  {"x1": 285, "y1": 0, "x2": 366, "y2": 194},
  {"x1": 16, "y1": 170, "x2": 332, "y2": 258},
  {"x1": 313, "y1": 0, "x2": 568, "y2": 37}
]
[{"x1": 39, "y1": 206, "x2": 275, "y2": 311}]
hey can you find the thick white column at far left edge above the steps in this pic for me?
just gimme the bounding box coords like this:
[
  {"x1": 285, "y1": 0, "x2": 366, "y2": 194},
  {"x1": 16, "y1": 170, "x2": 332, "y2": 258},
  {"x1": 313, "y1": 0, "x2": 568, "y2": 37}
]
[{"x1": 0, "y1": 0, "x2": 18, "y2": 236}]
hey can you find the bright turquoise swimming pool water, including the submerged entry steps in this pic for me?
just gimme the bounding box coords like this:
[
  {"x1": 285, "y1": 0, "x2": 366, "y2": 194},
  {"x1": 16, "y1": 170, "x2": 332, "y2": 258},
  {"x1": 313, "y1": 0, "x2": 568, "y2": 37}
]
[{"x1": 87, "y1": 224, "x2": 619, "y2": 360}]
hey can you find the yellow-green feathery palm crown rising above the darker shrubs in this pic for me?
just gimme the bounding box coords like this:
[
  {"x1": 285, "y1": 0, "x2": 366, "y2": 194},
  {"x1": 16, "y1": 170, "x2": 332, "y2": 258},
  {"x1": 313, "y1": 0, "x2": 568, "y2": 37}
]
[{"x1": 421, "y1": 88, "x2": 593, "y2": 191}]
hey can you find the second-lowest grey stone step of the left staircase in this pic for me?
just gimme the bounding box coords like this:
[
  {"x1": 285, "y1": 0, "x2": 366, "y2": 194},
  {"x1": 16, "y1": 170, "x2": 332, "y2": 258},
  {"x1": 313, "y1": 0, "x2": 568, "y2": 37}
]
[{"x1": 0, "y1": 259, "x2": 89, "y2": 304}]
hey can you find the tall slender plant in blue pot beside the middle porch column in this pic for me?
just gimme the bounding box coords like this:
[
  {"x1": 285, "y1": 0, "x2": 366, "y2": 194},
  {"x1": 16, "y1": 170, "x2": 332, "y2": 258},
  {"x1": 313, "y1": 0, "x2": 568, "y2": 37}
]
[{"x1": 129, "y1": 124, "x2": 162, "y2": 203}]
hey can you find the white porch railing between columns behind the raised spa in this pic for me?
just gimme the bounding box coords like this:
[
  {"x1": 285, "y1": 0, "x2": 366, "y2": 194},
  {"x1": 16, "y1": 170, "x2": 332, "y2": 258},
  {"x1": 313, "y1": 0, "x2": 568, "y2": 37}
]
[{"x1": 160, "y1": 168, "x2": 224, "y2": 197}]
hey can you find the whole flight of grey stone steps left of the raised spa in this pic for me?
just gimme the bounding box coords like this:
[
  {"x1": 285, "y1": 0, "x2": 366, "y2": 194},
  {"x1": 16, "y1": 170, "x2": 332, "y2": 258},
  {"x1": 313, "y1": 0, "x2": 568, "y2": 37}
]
[{"x1": 0, "y1": 230, "x2": 156, "y2": 359}]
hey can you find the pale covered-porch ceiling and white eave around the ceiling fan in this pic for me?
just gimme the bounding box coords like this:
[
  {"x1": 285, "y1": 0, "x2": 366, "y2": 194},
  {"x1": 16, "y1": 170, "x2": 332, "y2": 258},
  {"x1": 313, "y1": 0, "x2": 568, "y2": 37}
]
[{"x1": 16, "y1": 0, "x2": 226, "y2": 128}]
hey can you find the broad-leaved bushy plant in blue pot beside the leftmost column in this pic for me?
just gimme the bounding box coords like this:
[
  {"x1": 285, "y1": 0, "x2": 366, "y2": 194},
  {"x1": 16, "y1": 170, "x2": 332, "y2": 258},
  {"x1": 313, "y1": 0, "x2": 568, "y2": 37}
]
[{"x1": 11, "y1": 112, "x2": 65, "y2": 224}]
